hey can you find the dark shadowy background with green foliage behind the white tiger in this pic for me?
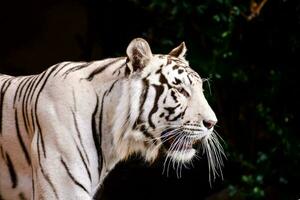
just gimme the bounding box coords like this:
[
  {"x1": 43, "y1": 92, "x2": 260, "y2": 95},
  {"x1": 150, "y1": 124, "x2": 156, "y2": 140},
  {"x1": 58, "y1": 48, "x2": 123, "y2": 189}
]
[{"x1": 0, "y1": 0, "x2": 300, "y2": 200}]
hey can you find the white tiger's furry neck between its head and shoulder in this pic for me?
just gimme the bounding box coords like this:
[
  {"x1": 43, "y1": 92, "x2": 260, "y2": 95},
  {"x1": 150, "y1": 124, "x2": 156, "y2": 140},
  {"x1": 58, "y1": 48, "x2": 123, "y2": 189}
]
[{"x1": 85, "y1": 58, "x2": 147, "y2": 191}]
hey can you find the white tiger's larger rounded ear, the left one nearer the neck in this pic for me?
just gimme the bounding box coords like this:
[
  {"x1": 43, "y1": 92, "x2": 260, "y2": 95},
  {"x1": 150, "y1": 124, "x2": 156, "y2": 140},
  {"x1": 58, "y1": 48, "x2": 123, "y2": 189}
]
[{"x1": 126, "y1": 38, "x2": 153, "y2": 71}]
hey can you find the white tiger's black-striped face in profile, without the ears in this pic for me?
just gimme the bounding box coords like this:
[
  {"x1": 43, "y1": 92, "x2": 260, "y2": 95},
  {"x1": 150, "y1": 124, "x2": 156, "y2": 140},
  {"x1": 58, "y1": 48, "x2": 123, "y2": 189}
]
[{"x1": 144, "y1": 56, "x2": 217, "y2": 159}]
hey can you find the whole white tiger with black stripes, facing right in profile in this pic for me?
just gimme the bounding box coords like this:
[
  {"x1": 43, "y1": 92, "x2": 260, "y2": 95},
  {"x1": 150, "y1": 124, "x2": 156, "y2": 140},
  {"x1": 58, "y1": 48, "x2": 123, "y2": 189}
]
[{"x1": 0, "y1": 38, "x2": 223, "y2": 200}]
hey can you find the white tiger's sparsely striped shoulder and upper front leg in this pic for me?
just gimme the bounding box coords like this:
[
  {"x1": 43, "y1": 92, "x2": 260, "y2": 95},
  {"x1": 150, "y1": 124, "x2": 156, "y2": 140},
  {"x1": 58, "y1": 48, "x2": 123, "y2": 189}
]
[{"x1": 27, "y1": 74, "x2": 105, "y2": 200}]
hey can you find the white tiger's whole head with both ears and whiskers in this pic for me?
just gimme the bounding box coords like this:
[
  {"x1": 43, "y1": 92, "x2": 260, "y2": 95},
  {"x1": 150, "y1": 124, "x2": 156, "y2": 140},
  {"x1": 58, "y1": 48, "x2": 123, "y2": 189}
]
[{"x1": 114, "y1": 38, "x2": 223, "y2": 180}]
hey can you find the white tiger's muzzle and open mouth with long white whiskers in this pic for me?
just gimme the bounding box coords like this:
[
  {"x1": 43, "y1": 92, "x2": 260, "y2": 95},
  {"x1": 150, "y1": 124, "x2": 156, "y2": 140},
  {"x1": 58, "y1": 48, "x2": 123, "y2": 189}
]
[{"x1": 160, "y1": 124, "x2": 226, "y2": 182}]
